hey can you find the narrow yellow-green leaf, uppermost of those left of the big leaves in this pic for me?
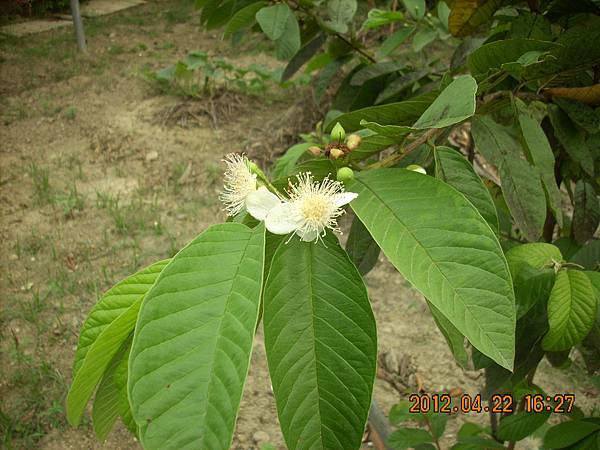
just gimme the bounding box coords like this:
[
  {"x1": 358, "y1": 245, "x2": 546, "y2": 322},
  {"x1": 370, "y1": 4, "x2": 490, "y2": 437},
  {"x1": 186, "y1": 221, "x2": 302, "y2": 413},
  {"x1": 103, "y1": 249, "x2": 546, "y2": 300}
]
[{"x1": 73, "y1": 259, "x2": 169, "y2": 378}]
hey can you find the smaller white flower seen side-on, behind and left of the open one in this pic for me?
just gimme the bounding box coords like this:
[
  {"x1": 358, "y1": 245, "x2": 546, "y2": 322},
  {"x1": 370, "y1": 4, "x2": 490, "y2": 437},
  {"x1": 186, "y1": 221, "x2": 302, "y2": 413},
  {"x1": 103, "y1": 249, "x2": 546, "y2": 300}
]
[{"x1": 219, "y1": 153, "x2": 257, "y2": 216}]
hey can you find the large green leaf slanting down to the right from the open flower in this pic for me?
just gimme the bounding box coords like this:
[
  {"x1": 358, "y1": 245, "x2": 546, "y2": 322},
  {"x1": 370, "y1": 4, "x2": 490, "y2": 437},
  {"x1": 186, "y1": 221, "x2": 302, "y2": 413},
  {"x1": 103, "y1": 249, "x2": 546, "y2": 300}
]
[{"x1": 349, "y1": 169, "x2": 515, "y2": 369}]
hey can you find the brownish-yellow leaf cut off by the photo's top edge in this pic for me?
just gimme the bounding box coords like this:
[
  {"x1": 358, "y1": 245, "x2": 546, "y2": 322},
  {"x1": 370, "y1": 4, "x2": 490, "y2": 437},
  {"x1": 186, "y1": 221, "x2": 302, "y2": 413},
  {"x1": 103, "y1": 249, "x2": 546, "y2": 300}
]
[{"x1": 448, "y1": 0, "x2": 502, "y2": 36}]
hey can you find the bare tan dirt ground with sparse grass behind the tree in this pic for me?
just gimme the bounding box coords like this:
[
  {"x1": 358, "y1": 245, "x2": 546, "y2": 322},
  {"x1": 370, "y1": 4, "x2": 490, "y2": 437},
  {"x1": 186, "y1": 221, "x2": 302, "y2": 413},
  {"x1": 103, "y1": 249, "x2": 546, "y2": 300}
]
[{"x1": 0, "y1": 0, "x2": 599, "y2": 450}]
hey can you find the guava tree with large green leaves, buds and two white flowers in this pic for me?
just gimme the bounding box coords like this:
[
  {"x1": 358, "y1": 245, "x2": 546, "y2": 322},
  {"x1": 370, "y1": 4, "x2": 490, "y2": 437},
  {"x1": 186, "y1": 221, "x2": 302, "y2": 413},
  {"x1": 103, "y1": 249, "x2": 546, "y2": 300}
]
[{"x1": 67, "y1": 0, "x2": 600, "y2": 450}]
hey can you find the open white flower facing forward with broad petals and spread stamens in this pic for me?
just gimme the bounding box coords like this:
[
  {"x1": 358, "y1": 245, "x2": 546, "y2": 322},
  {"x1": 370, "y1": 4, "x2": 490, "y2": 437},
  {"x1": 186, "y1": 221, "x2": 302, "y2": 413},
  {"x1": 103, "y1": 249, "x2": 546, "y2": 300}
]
[{"x1": 262, "y1": 172, "x2": 358, "y2": 242}]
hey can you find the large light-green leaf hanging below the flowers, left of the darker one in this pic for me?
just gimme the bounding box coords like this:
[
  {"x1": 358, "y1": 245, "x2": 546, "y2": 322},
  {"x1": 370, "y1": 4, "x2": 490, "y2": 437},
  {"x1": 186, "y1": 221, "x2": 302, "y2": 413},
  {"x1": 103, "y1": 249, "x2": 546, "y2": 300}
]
[{"x1": 128, "y1": 223, "x2": 264, "y2": 450}]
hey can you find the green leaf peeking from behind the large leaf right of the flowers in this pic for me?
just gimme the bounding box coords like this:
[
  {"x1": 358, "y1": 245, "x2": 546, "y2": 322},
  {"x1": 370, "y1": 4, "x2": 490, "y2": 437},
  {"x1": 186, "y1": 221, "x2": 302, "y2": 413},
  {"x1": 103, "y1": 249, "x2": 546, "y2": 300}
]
[{"x1": 434, "y1": 147, "x2": 499, "y2": 233}]
